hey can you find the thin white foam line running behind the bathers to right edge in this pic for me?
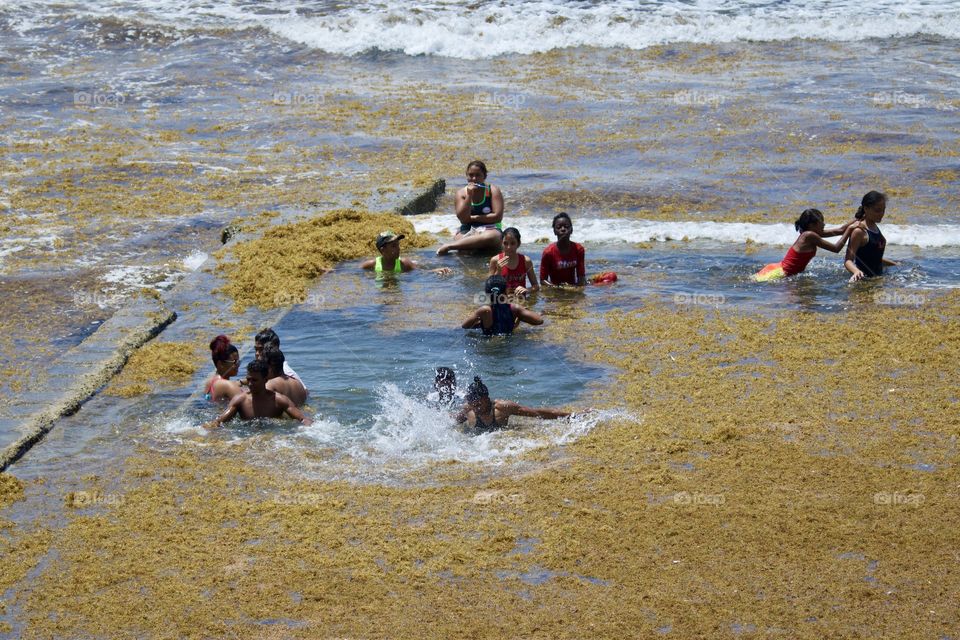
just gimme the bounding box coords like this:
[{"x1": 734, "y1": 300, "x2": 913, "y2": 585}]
[{"x1": 411, "y1": 214, "x2": 960, "y2": 247}]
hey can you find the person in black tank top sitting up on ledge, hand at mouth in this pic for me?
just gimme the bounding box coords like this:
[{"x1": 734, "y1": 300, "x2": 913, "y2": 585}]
[{"x1": 437, "y1": 160, "x2": 503, "y2": 256}]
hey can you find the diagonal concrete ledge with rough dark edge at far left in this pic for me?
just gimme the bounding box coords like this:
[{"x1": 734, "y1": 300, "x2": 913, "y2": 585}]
[{"x1": 0, "y1": 299, "x2": 177, "y2": 471}]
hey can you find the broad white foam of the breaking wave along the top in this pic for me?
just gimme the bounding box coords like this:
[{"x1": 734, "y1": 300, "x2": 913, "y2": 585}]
[{"x1": 7, "y1": 0, "x2": 960, "y2": 59}]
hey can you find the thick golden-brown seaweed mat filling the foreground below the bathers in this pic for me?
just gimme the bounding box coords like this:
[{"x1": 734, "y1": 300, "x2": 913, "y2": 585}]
[{"x1": 3, "y1": 293, "x2": 960, "y2": 638}]
